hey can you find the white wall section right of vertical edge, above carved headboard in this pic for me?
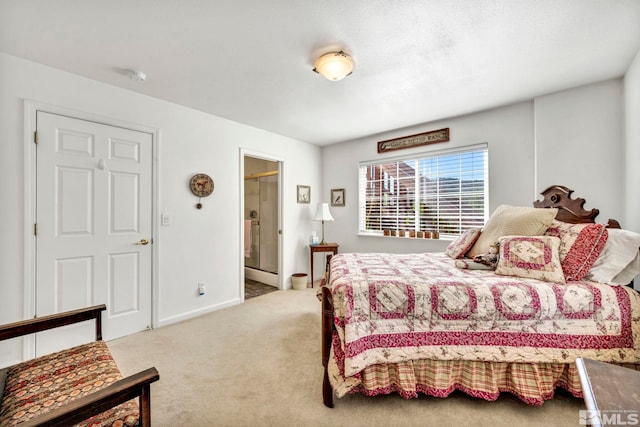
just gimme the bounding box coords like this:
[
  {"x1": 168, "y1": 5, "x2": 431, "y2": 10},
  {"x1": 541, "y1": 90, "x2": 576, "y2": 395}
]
[{"x1": 534, "y1": 79, "x2": 627, "y2": 226}]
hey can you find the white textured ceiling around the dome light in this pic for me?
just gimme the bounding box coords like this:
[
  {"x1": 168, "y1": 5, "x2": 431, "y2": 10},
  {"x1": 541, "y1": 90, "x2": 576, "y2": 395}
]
[{"x1": 0, "y1": 0, "x2": 640, "y2": 145}]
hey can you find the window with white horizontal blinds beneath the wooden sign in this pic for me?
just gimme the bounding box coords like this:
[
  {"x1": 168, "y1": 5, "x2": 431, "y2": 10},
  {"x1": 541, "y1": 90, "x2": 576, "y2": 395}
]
[{"x1": 359, "y1": 144, "x2": 488, "y2": 236}]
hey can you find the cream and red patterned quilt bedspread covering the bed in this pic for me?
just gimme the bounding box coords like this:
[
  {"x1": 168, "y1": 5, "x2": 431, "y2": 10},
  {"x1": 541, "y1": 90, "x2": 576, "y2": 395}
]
[{"x1": 328, "y1": 253, "x2": 640, "y2": 376}]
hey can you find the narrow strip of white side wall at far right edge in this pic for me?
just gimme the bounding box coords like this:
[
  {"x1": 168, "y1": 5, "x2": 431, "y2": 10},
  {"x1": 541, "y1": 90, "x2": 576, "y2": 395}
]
[{"x1": 623, "y1": 51, "x2": 640, "y2": 234}]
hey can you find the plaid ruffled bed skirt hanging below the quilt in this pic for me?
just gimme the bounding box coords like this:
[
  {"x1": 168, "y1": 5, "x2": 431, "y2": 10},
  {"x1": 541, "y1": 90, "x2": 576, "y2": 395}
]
[{"x1": 329, "y1": 358, "x2": 640, "y2": 406}]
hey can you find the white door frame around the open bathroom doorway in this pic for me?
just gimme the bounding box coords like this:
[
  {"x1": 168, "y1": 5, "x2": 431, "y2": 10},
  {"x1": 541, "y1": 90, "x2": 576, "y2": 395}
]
[{"x1": 238, "y1": 147, "x2": 285, "y2": 302}]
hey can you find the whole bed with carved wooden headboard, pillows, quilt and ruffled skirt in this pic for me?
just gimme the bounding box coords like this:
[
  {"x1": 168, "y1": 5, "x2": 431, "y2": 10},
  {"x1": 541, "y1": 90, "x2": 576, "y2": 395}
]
[{"x1": 318, "y1": 186, "x2": 640, "y2": 407}]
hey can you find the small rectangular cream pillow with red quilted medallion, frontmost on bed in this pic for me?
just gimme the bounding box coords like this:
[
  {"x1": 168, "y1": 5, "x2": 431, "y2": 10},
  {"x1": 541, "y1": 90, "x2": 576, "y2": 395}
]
[{"x1": 496, "y1": 236, "x2": 565, "y2": 283}]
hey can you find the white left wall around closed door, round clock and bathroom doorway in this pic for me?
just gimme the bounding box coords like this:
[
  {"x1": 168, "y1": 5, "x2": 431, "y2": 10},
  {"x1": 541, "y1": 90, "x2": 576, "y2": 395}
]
[{"x1": 0, "y1": 54, "x2": 321, "y2": 366}]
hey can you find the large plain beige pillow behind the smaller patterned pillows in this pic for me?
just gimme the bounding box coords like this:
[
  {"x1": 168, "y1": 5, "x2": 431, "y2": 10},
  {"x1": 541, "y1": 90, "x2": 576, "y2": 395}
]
[{"x1": 467, "y1": 205, "x2": 558, "y2": 258}]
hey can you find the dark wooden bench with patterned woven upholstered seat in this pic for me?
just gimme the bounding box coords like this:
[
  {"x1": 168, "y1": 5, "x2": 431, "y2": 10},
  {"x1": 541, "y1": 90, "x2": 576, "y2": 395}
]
[{"x1": 0, "y1": 305, "x2": 159, "y2": 427}]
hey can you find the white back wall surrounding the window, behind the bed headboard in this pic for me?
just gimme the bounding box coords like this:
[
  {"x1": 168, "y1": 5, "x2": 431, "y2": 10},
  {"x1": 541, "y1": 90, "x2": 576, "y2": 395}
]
[{"x1": 322, "y1": 79, "x2": 624, "y2": 280}]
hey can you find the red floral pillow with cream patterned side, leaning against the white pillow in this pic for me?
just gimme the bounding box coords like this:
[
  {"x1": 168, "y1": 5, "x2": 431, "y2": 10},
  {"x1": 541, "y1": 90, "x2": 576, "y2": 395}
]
[{"x1": 544, "y1": 219, "x2": 609, "y2": 280}]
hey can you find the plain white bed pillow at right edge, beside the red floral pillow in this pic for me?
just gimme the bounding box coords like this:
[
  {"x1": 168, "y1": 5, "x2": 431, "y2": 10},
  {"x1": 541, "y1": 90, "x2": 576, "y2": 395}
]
[{"x1": 585, "y1": 228, "x2": 640, "y2": 284}]
